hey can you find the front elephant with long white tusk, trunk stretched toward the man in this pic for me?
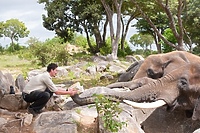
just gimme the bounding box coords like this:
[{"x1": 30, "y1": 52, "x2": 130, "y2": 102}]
[{"x1": 72, "y1": 63, "x2": 200, "y2": 120}]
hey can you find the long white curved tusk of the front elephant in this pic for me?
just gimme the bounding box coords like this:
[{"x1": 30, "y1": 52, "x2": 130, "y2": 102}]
[{"x1": 123, "y1": 100, "x2": 166, "y2": 108}]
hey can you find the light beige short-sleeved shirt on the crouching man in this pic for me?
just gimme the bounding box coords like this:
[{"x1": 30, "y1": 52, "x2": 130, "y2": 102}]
[{"x1": 23, "y1": 72, "x2": 58, "y2": 94}]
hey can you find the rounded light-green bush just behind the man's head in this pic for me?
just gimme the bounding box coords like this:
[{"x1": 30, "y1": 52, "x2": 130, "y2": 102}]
[{"x1": 25, "y1": 37, "x2": 69, "y2": 67}]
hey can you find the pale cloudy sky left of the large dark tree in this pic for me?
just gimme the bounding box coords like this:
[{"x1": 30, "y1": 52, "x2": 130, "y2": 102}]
[{"x1": 0, "y1": 0, "x2": 55, "y2": 46}]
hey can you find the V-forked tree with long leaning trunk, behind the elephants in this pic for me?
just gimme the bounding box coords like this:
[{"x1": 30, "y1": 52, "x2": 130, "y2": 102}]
[{"x1": 132, "y1": 0, "x2": 186, "y2": 50}]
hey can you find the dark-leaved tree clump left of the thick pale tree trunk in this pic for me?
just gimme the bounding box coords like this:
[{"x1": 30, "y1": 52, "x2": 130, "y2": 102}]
[{"x1": 39, "y1": 0, "x2": 108, "y2": 53}]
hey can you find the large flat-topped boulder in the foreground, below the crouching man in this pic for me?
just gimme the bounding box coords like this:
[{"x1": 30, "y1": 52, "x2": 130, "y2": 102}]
[{"x1": 33, "y1": 110, "x2": 78, "y2": 133}]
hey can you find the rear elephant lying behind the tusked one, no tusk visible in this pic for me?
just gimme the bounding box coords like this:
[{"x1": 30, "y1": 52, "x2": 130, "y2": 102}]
[{"x1": 107, "y1": 51, "x2": 200, "y2": 89}]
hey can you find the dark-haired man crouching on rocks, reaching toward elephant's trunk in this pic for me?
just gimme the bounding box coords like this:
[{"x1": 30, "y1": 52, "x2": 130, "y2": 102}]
[{"x1": 22, "y1": 63, "x2": 77, "y2": 116}]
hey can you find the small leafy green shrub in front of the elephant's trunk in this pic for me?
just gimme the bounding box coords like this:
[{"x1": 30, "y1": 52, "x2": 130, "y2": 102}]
[{"x1": 94, "y1": 94, "x2": 126, "y2": 132}]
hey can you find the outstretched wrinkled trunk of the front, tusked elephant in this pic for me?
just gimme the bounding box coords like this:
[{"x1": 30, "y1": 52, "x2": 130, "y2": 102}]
[{"x1": 72, "y1": 78, "x2": 179, "y2": 105}]
